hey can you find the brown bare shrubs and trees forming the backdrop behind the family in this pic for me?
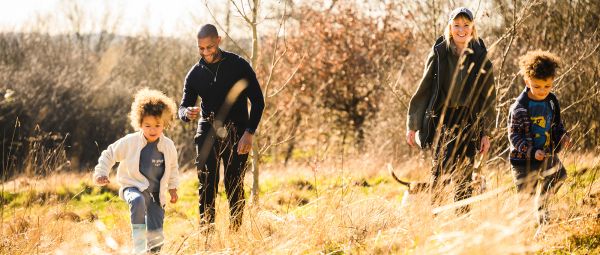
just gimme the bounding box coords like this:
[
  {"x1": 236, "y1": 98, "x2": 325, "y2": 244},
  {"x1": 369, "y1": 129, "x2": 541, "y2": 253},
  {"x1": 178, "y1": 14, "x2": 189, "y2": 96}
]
[{"x1": 0, "y1": 0, "x2": 600, "y2": 176}]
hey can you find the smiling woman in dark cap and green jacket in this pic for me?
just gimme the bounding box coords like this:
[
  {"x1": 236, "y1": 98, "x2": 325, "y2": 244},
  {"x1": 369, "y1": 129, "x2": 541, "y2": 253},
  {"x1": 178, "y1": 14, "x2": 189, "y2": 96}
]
[{"x1": 406, "y1": 7, "x2": 496, "y2": 211}]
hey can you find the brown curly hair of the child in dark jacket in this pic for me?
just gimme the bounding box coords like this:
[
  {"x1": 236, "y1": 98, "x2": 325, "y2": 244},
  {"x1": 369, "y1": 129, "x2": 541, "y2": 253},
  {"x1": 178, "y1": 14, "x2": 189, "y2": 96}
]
[{"x1": 519, "y1": 50, "x2": 561, "y2": 80}]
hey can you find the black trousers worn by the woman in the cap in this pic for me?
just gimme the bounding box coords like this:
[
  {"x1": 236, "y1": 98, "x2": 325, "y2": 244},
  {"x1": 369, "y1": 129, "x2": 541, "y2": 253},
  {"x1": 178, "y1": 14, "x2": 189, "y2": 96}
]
[{"x1": 430, "y1": 108, "x2": 480, "y2": 212}]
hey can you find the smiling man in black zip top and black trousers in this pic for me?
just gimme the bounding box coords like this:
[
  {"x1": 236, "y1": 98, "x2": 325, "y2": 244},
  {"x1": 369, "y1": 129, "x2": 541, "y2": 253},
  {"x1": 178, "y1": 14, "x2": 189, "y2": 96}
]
[{"x1": 178, "y1": 24, "x2": 264, "y2": 230}]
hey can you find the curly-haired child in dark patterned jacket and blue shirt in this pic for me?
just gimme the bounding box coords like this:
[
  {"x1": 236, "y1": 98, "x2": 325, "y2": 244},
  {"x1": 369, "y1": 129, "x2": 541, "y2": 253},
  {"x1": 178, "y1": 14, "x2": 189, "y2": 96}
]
[{"x1": 508, "y1": 50, "x2": 571, "y2": 224}]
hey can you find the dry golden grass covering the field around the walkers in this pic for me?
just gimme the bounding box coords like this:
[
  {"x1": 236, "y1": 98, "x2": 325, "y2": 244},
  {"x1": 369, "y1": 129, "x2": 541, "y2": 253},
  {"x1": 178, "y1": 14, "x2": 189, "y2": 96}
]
[{"x1": 0, "y1": 153, "x2": 600, "y2": 254}]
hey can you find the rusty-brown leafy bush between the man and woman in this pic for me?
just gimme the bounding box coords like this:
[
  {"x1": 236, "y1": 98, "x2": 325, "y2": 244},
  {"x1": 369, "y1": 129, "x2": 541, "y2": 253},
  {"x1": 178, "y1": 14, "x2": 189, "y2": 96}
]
[{"x1": 289, "y1": 5, "x2": 411, "y2": 146}]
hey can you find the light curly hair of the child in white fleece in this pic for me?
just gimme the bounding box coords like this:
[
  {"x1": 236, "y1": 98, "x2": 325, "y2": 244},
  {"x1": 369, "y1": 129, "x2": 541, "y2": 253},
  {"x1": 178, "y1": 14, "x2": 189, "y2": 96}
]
[{"x1": 129, "y1": 88, "x2": 177, "y2": 130}]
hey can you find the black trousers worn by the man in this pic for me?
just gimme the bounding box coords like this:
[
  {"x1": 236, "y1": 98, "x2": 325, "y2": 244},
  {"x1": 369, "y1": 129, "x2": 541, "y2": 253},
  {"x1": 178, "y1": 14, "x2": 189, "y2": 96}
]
[{"x1": 195, "y1": 125, "x2": 248, "y2": 230}]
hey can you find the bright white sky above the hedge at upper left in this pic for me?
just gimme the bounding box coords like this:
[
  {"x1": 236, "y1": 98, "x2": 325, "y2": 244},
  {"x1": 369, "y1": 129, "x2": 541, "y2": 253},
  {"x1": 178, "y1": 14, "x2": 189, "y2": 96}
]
[{"x1": 0, "y1": 0, "x2": 219, "y2": 37}]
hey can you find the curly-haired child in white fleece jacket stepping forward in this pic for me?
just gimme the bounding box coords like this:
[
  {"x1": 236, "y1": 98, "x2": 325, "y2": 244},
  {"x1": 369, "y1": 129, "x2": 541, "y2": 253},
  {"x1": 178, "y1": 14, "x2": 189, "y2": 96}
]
[{"x1": 93, "y1": 89, "x2": 179, "y2": 254}]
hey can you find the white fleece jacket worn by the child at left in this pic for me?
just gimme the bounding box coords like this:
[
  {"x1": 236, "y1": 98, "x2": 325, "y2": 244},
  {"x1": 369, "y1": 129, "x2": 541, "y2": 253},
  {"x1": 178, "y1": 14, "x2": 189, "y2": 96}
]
[{"x1": 93, "y1": 131, "x2": 179, "y2": 207}]
